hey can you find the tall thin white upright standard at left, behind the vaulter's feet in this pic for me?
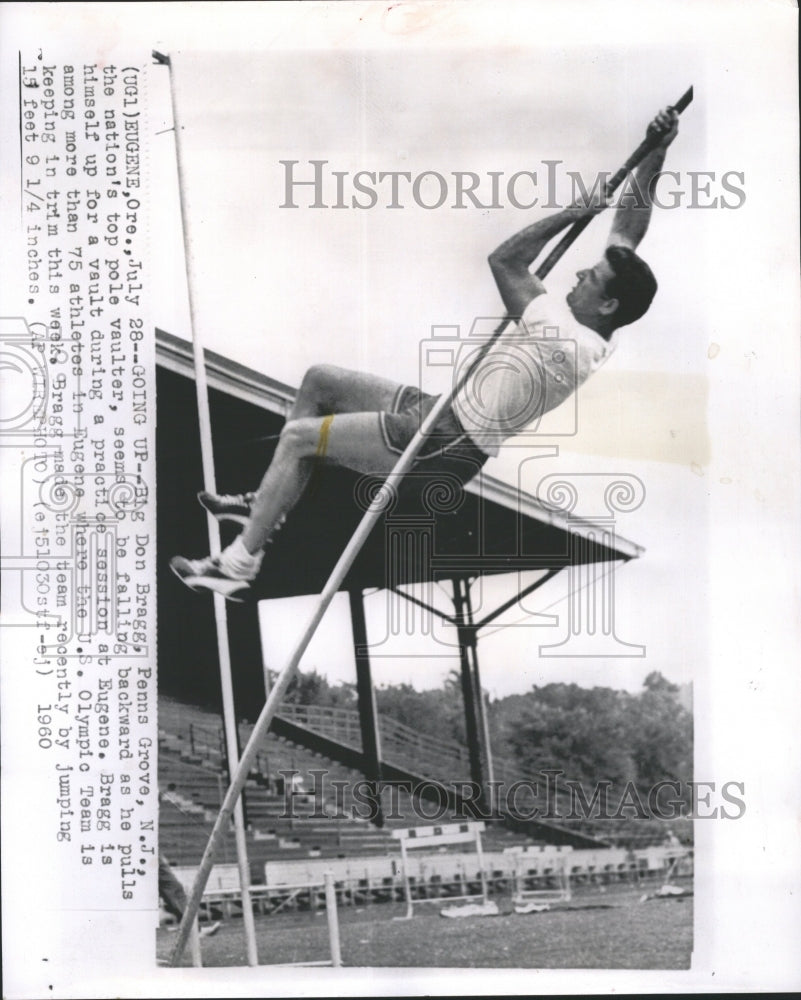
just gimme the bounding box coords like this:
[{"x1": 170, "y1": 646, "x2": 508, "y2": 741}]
[{"x1": 153, "y1": 52, "x2": 259, "y2": 965}]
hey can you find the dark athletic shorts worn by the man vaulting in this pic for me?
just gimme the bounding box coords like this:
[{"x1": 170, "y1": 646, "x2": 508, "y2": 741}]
[{"x1": 378, "y1": 385, "x2": 489, "y2": 483}]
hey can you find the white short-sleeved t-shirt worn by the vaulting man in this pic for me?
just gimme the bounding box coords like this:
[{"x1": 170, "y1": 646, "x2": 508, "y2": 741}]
[{"x1": 453, "y1": 293, "x2": 616, "y2": 455}]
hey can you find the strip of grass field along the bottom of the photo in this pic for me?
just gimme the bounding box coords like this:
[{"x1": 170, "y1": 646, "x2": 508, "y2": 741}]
[{"x1": 157, "y1": 892, "x2": 693, "y2": 969}]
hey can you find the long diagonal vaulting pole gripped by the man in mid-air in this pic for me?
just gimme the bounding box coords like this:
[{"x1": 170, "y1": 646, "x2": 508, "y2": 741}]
[{"x1": 170, "y1": 87, "x2": 692, "y2": 965}]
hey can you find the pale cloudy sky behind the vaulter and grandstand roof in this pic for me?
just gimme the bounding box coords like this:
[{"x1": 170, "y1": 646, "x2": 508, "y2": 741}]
[{"x1": 149, "y1": 47, "x2": 712, "y2": 697}]
